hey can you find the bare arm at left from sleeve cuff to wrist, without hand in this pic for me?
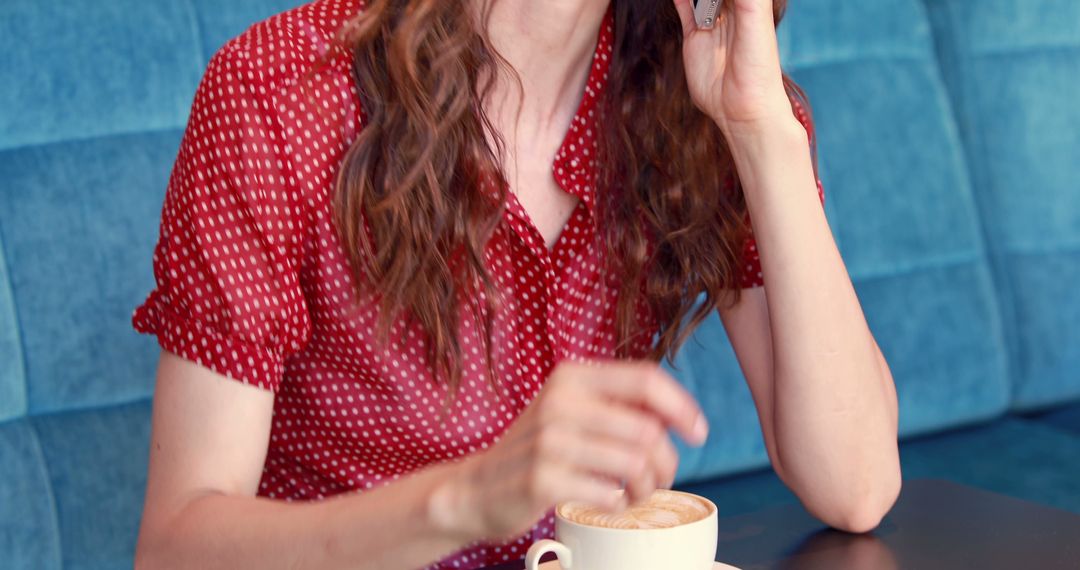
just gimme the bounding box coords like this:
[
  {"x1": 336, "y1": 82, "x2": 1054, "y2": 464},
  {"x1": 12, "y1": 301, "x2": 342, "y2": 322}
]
[{"x1": 135, "y1": 351, "x2": 474, "y2": 569}]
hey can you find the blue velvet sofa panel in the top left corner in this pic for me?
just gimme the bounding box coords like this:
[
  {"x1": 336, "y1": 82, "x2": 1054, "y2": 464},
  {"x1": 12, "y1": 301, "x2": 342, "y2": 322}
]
[{"x1": 0, "y1": 0, "x2": 198, "y2": 148}]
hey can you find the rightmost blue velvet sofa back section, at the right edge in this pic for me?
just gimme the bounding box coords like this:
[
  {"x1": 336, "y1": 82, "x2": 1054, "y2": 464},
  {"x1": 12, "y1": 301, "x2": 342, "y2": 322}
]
[{"x1": 927, "y1": 0, "x2": 1080, "y2": 409}]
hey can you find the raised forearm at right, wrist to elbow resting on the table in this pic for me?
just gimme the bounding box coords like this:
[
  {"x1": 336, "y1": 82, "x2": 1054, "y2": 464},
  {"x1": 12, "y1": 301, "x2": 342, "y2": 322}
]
[{"x1": 732, "y1": 120, "x2": 900, "y2": 528}]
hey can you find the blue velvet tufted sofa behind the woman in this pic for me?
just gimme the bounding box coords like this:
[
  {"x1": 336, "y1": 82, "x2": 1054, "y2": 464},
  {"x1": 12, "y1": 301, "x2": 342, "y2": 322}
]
[{"x1": 0, "y1": 0, "x2": 1080, "y2": 569}]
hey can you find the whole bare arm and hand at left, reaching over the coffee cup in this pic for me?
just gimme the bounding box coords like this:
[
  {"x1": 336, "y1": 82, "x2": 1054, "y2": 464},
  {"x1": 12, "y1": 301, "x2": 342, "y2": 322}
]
[{"x1": 135, "y1": 351, "x2": 705, "y2": 569}]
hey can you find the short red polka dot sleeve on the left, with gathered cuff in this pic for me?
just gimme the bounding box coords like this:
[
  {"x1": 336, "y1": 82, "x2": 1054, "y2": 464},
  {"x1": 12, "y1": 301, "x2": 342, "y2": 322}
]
[{"x1": 132, "y1": 43, "x2": 311, "y2": 391}]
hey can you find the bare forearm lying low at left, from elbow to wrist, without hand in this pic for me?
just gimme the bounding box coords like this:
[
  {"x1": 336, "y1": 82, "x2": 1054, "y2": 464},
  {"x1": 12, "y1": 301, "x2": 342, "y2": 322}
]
[{"x1": 136, "y1": 465, "x2": 472, "y2": 570}]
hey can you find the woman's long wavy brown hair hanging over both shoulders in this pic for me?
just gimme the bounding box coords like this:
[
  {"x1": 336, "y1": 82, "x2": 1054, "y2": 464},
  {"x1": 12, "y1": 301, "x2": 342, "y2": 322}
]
[{"x1": 311, "y1": 0, "x2": 812, "y2": 394}]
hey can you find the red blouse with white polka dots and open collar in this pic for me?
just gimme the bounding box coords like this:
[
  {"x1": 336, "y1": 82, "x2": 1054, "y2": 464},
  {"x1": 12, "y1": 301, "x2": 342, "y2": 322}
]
[{"x1": 133, "y1": 0, "x2": 820, "y2": 568}]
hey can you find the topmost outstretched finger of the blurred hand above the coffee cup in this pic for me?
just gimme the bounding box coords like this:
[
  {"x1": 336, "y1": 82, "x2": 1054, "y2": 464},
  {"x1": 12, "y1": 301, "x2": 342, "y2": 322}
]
[{"x1": 584, "y1": 363, "x2": 708, "y2": 445}]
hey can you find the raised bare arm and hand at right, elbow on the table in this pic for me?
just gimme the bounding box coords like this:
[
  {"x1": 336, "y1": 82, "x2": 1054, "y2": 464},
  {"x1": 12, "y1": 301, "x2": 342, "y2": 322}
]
[{"x1": 673, "y1": 0, "x2": 901, "y2": 532}]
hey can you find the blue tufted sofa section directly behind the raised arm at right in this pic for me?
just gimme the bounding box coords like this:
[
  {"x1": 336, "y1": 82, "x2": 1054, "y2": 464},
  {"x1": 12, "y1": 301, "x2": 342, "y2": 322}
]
[{"x1": 676, "y1": 0, "x2": 1009, "y2": 480}]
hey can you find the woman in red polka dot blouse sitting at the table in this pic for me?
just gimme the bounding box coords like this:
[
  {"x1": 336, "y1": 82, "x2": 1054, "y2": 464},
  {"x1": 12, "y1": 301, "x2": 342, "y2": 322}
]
[{"x1": 134, "y1": 0, "x2": 900, "y2": 569}]
